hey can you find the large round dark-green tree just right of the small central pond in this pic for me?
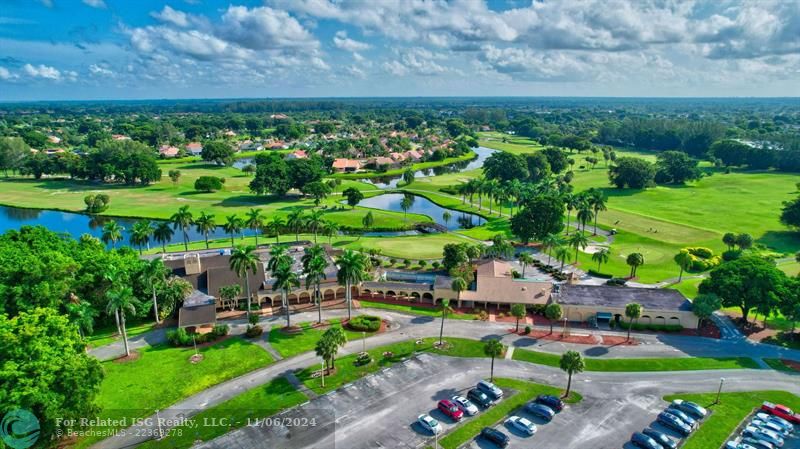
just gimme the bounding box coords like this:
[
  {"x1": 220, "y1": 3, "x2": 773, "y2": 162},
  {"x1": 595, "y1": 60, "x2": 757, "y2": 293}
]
[{"x1": 511, "y1": 195, "x2": 564, "y2": 243}]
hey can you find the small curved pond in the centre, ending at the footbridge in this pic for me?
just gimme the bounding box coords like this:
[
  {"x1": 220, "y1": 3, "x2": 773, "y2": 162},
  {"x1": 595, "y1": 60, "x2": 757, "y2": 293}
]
[{"x1": 358, "y1": 193, "x2": 486, "y2": 231}]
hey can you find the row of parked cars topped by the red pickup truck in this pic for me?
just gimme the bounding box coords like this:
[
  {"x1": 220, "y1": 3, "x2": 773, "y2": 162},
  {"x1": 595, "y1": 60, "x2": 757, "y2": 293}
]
[{"x1": 725, "y1": 402, "x2": 800, "y2": 449}]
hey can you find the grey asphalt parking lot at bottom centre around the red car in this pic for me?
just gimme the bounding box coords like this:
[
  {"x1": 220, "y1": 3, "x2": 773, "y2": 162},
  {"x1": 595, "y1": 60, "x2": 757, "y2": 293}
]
[{"x1": 199, "y1": 354, "x2": 692, "y2": 449}]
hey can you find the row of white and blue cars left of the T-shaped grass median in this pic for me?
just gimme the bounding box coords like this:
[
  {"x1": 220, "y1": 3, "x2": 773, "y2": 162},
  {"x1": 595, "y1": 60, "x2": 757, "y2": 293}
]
[{"x1": 631, "y1": 399, "x2": 708, "y2": 449}]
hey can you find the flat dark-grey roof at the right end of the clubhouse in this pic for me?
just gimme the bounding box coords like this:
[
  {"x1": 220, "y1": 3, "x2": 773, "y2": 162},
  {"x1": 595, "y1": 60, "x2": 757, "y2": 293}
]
[{"x1": 556, "y1": 284, "x2": 692, "y2": 311}]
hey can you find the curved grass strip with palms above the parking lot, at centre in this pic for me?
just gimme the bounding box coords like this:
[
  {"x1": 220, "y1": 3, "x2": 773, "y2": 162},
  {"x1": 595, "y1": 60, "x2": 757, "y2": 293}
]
[{"x1": 297, "y1": 337, "x2": 500, "y2": 394}]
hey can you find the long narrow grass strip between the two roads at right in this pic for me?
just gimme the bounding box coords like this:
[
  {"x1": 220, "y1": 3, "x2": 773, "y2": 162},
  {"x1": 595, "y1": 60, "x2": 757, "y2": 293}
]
[{"x1": 512, "y1": 348, "x2": 759, "y2": 372}]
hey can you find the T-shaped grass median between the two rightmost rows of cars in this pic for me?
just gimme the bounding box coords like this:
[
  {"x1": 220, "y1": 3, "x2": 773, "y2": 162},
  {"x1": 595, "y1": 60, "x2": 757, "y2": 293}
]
[{"x1": 664, "y1": 391, "x2": 800, "y2": 449}]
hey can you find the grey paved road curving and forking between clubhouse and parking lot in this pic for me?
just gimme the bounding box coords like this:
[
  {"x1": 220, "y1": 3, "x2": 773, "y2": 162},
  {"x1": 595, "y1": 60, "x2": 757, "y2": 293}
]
[{"x1": 87, "y1": 310, "x2": 800, "y2": 448}]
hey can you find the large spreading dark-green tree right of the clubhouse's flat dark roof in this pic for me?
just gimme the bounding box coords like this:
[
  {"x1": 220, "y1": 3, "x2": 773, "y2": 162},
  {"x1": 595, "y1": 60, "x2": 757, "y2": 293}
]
[{"x1": 699, "y1": 255, "x2": 786, "y2": 323}]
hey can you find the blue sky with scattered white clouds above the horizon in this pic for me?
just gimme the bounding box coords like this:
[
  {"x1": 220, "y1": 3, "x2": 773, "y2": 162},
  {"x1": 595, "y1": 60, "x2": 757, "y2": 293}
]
[{"x1": 0, "y1": 0, "x2": 800, "y2": 101}]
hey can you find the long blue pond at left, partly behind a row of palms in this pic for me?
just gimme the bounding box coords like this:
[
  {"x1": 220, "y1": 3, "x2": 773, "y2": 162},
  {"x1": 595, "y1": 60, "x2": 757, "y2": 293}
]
[{"x1": 0, "y1": 206, "x2": 252, "y2": 246}]
